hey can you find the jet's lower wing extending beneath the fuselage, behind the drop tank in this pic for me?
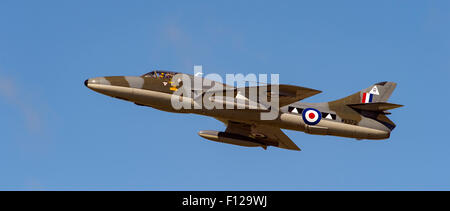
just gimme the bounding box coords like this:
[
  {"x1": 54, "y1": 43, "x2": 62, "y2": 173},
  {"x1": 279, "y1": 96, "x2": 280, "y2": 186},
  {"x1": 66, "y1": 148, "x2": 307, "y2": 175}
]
[{"x1": 221, "y1": 120, "x2": 300, "y2": 151}]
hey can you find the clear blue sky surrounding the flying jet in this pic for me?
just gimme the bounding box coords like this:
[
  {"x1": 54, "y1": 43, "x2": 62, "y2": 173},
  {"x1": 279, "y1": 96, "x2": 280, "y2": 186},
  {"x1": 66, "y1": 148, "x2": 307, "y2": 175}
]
[{"x1": 0, "y1": 0, "x2": 450, "y2": 190}]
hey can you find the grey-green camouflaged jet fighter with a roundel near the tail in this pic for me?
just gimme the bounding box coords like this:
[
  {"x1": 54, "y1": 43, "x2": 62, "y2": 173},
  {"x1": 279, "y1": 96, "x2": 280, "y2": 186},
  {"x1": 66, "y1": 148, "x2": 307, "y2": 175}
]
[{"x1": 84, "y1": 70, "x2": 402, "y2": 151}]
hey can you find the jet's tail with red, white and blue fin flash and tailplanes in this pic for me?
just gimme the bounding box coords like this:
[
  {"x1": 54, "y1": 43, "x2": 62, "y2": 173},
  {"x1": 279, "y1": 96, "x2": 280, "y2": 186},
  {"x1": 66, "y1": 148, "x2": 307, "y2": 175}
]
[{"x1": 328, "y1": 81, "x2": 402, "y2": 130}]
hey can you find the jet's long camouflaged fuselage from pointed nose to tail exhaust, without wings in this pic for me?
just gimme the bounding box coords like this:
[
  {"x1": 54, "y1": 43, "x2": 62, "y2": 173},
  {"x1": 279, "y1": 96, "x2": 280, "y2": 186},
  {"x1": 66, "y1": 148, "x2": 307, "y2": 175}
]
[{"x1": 85, "y1": 73, "x2": 390, "y2": 139}]
